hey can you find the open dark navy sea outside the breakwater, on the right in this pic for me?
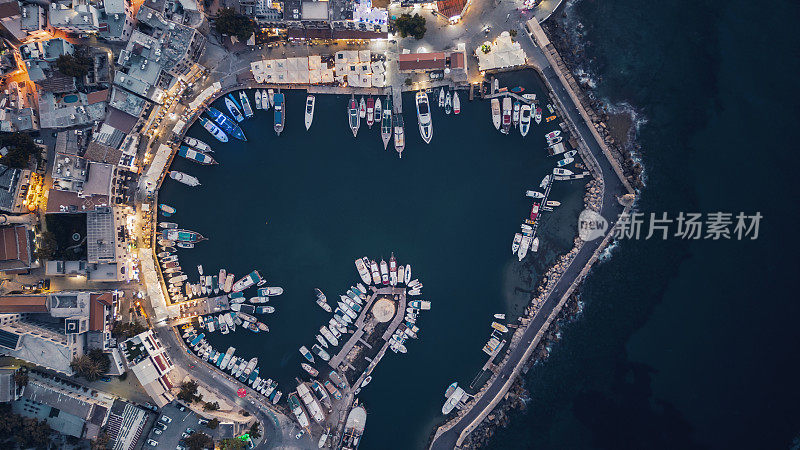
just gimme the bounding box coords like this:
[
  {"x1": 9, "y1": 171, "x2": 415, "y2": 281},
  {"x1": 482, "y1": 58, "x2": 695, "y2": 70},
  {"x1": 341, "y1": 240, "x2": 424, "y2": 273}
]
[{"x1": 491, "y1": 0, "x2": 800, "y2": 449}]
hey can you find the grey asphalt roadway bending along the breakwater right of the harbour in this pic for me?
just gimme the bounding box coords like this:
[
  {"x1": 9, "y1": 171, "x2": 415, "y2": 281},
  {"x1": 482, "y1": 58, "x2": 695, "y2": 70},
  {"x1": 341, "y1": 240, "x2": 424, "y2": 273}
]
[{"x1": 431, "y1": 30, "x2": 628, "y2": 449}]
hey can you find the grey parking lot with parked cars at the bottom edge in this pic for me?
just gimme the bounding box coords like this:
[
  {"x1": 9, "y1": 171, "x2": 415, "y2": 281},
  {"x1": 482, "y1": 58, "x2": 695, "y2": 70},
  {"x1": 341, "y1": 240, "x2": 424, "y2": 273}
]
[{"x1": 142, "y1": 402, "x2": 225, "y2": 449}]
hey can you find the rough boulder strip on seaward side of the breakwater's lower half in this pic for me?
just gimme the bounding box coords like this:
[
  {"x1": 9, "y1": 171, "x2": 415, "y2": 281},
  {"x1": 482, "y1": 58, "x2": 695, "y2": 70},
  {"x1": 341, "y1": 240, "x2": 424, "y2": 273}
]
[{"x1": 462, "y1": 293, "x2": 583, "y2": 448}]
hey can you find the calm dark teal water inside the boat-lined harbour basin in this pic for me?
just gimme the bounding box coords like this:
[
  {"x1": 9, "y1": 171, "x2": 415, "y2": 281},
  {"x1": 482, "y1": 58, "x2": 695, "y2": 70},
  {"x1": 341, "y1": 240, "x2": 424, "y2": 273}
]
[{"x1": 159, "y1": 84, "x2": 584, "y2": 449}]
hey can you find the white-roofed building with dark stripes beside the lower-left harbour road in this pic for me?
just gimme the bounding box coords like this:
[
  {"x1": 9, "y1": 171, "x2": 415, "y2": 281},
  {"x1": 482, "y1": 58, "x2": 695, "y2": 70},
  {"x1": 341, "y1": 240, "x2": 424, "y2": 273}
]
[{"x1": 120, "y1": 330, "x2": 175, "y2": 408}]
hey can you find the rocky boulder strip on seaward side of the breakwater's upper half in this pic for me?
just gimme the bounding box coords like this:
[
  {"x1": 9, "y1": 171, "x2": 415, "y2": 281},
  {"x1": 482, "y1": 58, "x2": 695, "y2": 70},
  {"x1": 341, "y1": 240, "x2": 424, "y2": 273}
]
[{"x1": 542, "y1": 14, "x2": 644, "y2": 189}]
